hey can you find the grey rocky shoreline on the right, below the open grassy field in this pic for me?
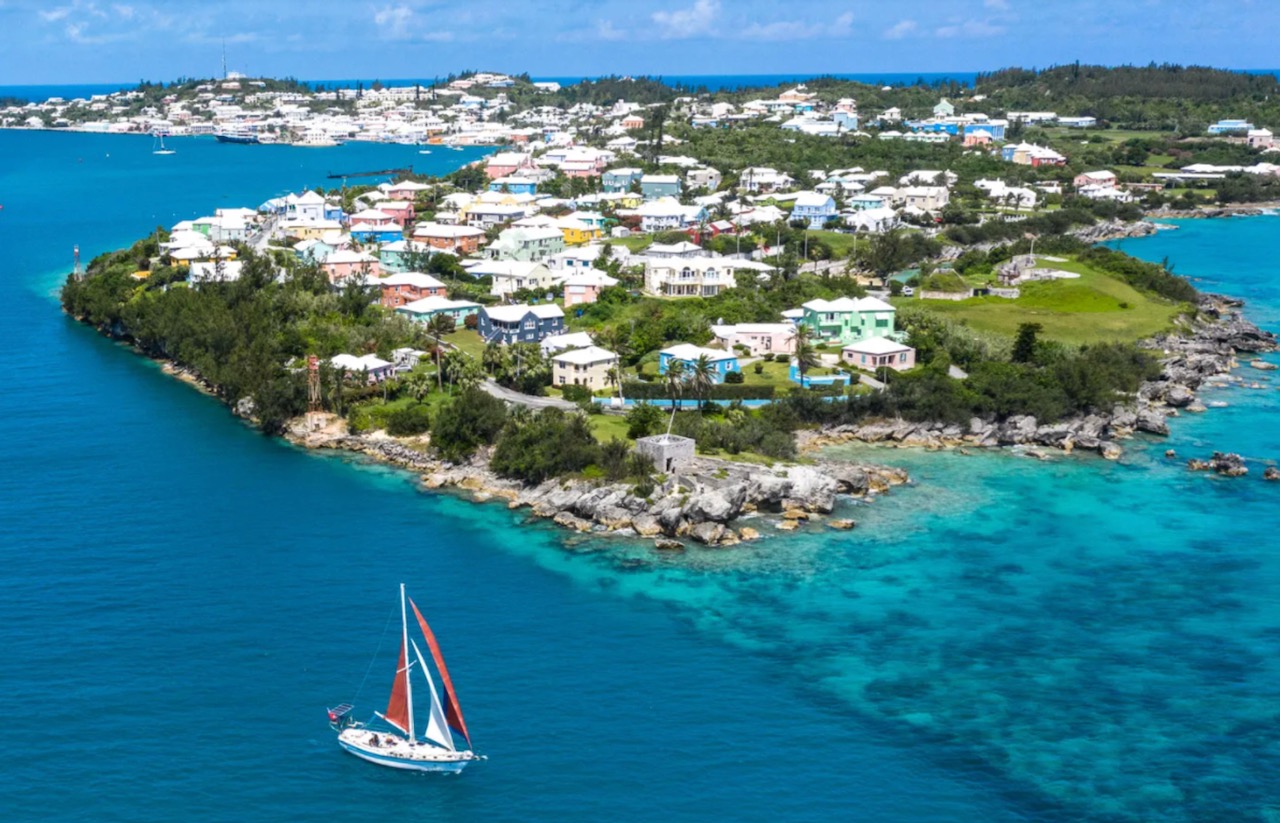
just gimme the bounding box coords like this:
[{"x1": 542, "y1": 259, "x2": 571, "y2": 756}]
[{"x1": 799, "y1": 294, "x2": 1277, "y2": 459}]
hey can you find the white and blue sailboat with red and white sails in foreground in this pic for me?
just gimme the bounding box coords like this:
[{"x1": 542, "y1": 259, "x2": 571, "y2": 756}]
[{"x1": 329, "y1": 584, "x2": 484, "y2": 773}]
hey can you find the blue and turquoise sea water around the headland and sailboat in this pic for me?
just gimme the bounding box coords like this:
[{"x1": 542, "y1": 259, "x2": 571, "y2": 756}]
[{"x1": 0, "y1": 132, "x2": 1280, "y2": 823}]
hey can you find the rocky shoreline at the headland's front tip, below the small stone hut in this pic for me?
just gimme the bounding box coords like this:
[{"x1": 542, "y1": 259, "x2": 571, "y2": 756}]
[{"x1": 285, "y1": 417, "x2": 909, "y2": 549}]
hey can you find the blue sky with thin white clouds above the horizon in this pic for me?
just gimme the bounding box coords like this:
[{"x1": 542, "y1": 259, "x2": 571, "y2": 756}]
[{"x1": 0, "y1": 0, "x2": 1280, "y2": 86}]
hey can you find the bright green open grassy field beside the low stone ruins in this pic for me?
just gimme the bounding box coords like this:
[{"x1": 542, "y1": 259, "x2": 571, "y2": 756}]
[{"x1": 895, "y1": 260, "x2": 1185, "y2": 346}]
